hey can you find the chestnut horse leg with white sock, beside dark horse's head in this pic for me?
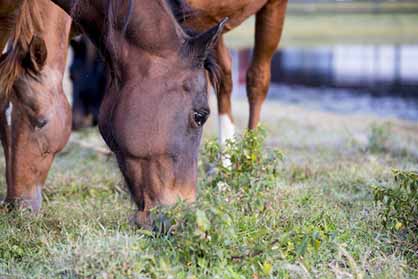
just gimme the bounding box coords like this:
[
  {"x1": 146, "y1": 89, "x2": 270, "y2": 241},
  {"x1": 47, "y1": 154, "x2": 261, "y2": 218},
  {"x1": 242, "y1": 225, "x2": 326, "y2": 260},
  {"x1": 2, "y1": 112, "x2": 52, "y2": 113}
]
[{"x1": 216, "y1": 37, "x2": 235, "y2": 144}]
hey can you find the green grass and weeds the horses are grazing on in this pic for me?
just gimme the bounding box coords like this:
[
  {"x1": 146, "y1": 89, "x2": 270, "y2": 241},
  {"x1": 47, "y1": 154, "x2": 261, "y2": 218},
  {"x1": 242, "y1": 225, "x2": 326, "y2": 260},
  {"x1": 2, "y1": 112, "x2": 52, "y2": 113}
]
[{"x1": 0, "y1": 100, "x2": 418, "y2": 278}]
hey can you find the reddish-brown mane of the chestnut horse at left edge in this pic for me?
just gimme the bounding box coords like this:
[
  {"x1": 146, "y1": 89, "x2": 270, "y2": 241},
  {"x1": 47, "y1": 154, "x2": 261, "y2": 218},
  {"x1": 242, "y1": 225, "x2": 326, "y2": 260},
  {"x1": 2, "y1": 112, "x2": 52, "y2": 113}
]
[{"x1": 0, "y1": 0, "x2": 43, "y2": 102}]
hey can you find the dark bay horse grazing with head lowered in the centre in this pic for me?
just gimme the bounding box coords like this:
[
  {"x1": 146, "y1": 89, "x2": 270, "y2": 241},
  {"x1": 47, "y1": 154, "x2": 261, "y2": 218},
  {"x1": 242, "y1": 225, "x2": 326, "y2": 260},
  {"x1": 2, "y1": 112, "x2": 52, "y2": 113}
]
[{"x1": 53, "y1": 0, "x2": 226, "y2": 226}]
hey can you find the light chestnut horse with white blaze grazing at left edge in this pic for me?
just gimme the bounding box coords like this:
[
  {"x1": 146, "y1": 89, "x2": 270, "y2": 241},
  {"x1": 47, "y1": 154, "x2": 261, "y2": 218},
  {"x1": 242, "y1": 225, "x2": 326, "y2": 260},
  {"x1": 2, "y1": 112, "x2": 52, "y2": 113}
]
[{"x1": 0, "y1": 0, "x2": 71, "y2": 212}]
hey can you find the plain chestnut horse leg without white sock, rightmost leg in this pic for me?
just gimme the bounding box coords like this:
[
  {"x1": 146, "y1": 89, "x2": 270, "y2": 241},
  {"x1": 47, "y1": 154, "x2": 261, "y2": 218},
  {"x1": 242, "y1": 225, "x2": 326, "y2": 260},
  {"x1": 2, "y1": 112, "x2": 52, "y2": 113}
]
[{"x1": 247, "y1": 0, "x2": 287, "y2": 129}]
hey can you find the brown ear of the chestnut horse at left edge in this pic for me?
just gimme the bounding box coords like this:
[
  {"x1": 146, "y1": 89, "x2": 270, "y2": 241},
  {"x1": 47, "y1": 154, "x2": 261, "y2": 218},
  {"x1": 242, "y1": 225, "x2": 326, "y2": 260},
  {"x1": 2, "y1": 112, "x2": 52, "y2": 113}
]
[{"x1": 22, "y1": 36, "x2": 48, "y2": 73}]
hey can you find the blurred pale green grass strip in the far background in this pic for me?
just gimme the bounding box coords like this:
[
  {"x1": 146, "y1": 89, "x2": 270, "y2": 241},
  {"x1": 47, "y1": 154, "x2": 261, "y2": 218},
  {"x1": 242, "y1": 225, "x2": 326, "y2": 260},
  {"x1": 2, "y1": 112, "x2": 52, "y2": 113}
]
[{"x1": 226, "y1": 13, "x2": 418, "y2": 48}]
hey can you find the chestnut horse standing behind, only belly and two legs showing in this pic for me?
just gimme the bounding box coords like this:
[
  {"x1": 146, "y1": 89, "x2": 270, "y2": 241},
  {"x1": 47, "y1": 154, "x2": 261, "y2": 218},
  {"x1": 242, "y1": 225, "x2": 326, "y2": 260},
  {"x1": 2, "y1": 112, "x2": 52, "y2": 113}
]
[{"x1": 168, "y1": 0, "x2": 287, "y2": 143}]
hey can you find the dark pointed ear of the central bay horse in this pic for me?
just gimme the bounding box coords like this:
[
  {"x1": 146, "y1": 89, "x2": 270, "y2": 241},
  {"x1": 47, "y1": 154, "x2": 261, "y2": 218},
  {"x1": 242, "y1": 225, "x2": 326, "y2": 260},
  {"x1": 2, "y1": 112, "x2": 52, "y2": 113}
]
[{"x1": 189, "y1": 17, "x2": 229, "y2": 62}]
